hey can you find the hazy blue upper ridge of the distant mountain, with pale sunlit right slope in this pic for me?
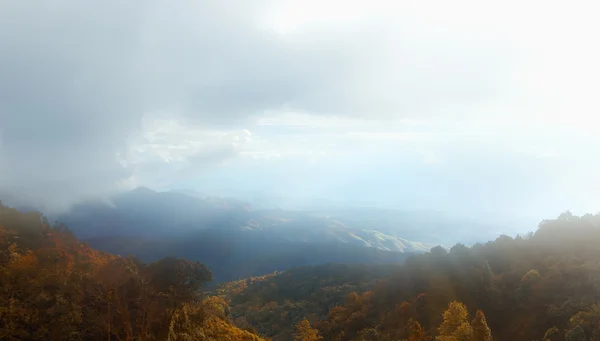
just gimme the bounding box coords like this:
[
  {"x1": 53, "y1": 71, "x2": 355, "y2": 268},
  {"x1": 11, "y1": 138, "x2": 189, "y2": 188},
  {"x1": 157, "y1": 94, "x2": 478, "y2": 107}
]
[{"x1": 58, "y1": 187, "x2": 434, "y2": 252}]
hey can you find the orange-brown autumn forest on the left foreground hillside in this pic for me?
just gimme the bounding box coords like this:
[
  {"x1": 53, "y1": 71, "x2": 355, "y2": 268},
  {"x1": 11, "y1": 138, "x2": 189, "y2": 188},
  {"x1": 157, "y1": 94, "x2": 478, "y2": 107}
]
[{"x1": 0, "y1": 204, "x2": 261, "y2": 341}]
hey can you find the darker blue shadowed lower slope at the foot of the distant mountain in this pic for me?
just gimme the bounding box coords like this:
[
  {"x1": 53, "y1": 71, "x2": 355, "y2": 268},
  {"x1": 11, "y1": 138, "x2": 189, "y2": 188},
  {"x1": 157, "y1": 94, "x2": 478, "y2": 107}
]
[{"x1": 83, "y1": 231, "x2": 410, "y2": 282}]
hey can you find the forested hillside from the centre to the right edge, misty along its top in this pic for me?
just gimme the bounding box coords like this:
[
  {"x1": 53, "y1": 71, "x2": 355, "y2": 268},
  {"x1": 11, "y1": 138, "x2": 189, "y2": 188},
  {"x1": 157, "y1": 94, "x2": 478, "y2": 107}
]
[{"x1": 224, "y1": 213, "x2": 600, "y2": 341}]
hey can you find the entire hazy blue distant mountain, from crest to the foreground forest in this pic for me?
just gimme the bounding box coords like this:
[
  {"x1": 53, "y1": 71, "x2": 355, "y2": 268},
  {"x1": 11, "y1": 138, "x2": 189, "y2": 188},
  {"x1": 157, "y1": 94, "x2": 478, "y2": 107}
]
[{"x1": 58, "y1": 188, "x2": 433, "y2": 281}]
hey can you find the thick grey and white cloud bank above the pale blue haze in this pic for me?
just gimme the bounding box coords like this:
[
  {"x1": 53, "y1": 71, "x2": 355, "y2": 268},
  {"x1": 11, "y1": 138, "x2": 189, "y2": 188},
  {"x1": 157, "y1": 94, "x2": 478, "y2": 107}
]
[{"x1": 0, "y1": 0, "x2": 600, "y2": 212}]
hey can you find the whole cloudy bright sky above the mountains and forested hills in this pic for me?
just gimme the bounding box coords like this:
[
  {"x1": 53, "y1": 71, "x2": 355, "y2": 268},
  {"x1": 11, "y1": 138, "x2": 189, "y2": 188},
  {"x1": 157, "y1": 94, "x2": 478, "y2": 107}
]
[{"x1": 0, "y1": 0, "x2": 600, "y2": 218}]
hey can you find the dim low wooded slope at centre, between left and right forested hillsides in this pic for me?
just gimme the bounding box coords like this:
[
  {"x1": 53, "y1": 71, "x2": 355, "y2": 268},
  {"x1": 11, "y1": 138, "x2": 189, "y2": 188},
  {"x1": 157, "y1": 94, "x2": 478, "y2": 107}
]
[{"x1": 217, "y1": 264, "x2": 399, "y2": 340}]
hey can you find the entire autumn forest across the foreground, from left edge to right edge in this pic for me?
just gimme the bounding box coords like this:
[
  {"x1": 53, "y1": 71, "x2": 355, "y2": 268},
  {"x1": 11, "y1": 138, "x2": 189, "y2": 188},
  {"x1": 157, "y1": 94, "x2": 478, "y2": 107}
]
[{"x1": 0, "y1": 199, "x2": 600, "y2": 341}]
